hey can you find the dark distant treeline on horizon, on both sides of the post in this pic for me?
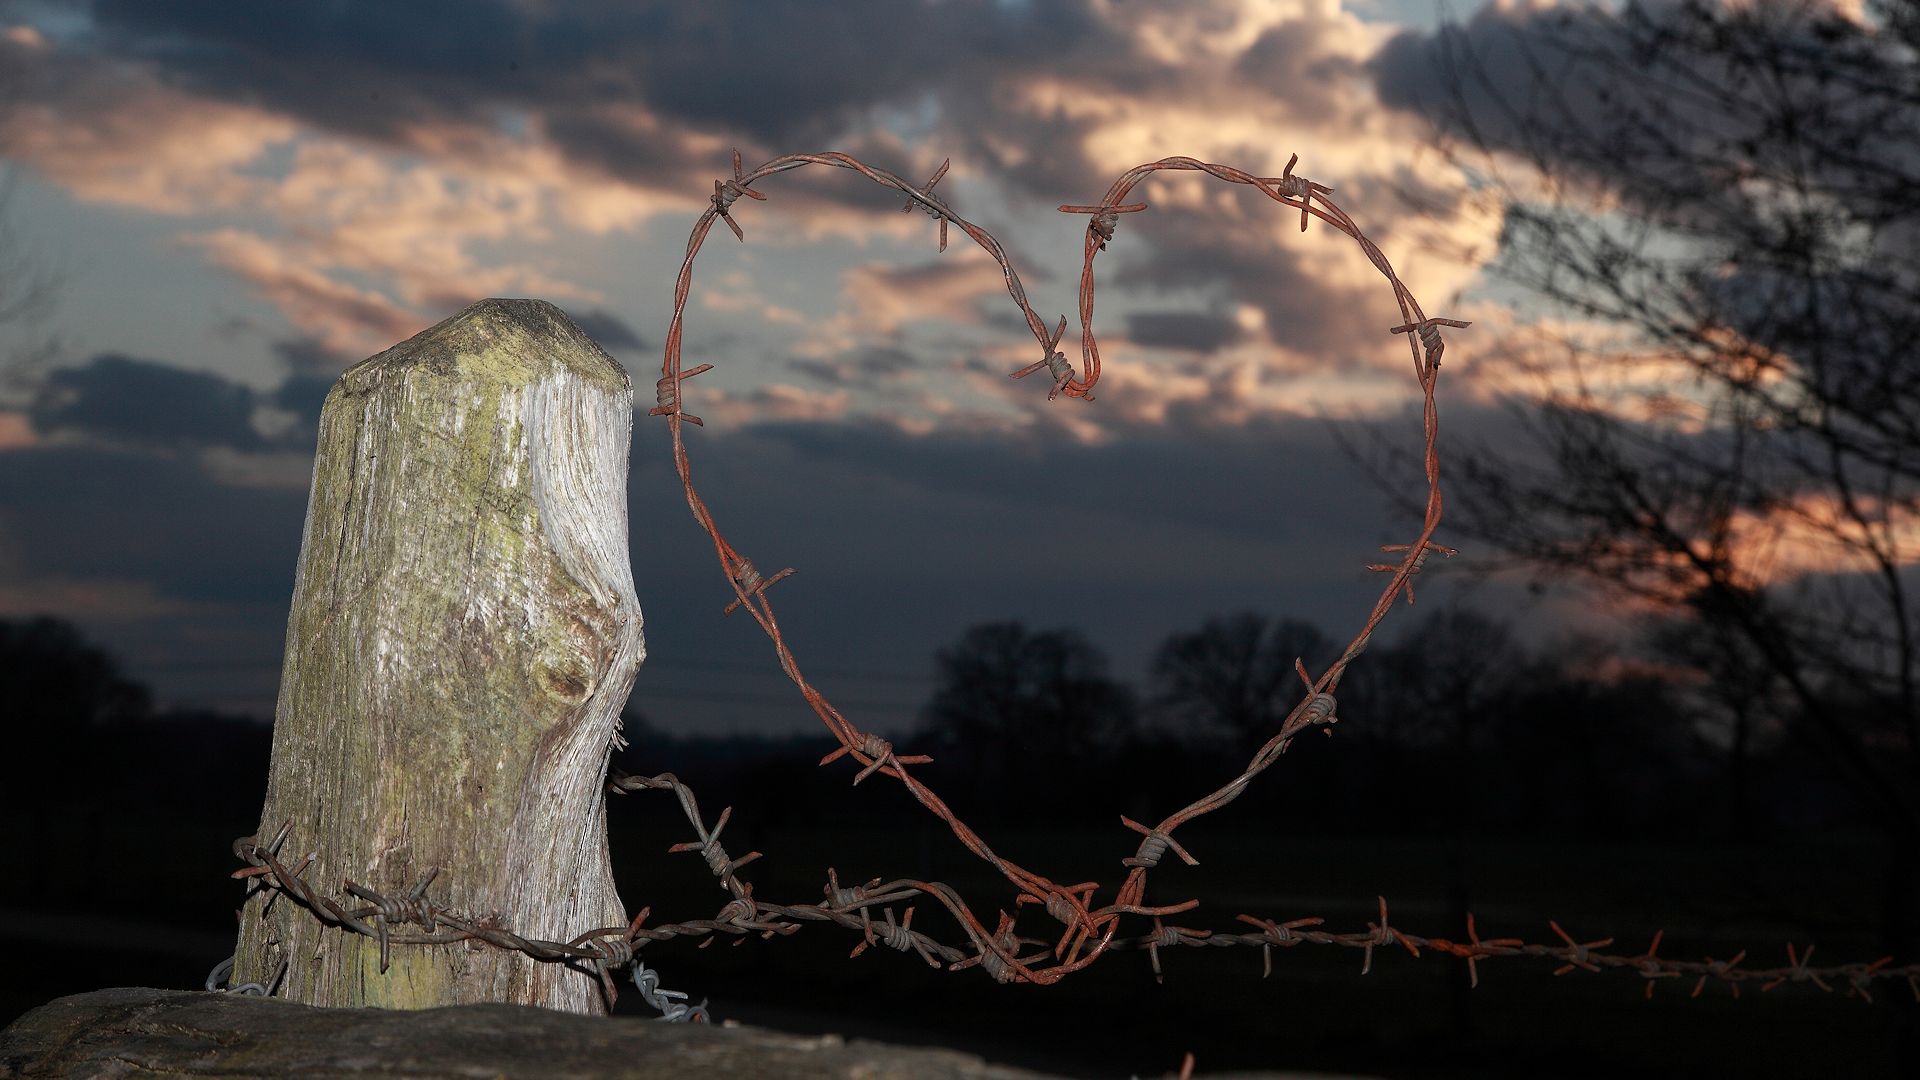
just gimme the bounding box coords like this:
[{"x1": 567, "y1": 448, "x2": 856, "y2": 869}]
[{"x1": 0, "y1": 609, "x2": 1857, "y2": 836}]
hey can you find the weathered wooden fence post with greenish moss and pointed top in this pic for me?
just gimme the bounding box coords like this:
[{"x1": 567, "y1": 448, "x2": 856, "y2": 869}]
[{"x1": 234, "y1": 300, "x2": 645, "y2": 1013}]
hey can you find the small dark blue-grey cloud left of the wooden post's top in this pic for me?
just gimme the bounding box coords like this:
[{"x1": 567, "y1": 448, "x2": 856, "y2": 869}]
[{"x1": 27, "y1": 354, "x2": 265, "y2": 450}]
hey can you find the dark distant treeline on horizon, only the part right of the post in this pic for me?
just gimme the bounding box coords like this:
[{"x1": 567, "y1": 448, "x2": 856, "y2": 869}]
[{"x1": 616, "y1": 609, "x2": 1864, "y2": 838}]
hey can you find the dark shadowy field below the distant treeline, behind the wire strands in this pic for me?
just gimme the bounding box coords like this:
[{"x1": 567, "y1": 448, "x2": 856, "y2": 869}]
[{"x1": 0, "y1": 759, "x2": 1889, "y2": 1078}]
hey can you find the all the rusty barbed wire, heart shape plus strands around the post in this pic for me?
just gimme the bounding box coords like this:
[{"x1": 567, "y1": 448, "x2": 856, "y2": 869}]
[{"x1": 220, "y1": 152, "x2": 1920, "y2": 1019}]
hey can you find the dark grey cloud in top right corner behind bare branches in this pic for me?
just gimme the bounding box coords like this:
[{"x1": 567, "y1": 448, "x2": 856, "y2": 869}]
[{"x1": 1367, "y1": 0, "x2": 1889, "y2": 205}]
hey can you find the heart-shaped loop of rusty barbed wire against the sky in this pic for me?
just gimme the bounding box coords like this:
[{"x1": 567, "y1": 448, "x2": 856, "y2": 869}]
[{"x1": 651, "y1": 150, "x2": 1467, "y2": 984}]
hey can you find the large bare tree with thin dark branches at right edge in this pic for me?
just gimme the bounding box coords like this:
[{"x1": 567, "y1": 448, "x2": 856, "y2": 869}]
[{"x1": 1379, "y1": 0, "x2": 1920, "y2": 1037}]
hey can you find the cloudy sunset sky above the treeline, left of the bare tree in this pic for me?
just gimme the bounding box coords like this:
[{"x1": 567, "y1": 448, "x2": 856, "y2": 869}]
[{"x1": 0, "y1": 0, "x2": 1804, "y2": 732}]
